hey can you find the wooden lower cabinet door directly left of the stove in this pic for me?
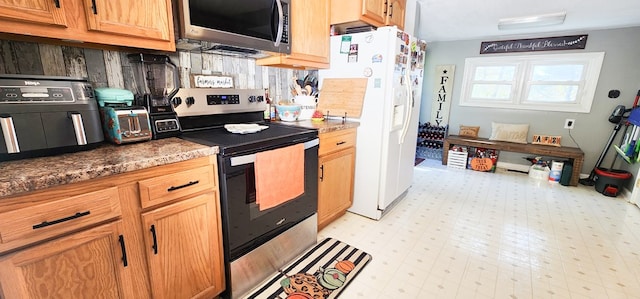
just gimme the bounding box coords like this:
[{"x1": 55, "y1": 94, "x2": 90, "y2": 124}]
[{"x1": 142, "y1": 193, "x2": 224, "y2": 298}]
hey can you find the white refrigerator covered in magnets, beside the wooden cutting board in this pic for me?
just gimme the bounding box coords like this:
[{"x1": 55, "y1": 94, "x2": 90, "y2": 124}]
[{"x1": 318, "y1": 27, "x2": 426, "y2": 220}]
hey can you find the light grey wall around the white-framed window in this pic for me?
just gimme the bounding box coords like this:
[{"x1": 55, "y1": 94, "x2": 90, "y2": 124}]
[{"x1": 420, "y1": 27, "x2": 640, "y2": 174}]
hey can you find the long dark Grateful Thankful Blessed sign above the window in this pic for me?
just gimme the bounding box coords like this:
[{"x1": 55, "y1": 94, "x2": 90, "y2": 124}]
[{"x1": 480, "y1": 34, "x2": 587, "y2": 54}]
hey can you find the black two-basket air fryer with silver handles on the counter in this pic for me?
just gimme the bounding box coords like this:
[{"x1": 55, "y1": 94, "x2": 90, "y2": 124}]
[{"x1": 0, "y1": 75, "x2": 104, "y2": 161}]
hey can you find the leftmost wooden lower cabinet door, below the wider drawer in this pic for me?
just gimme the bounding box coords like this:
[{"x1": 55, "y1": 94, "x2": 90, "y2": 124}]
[{"x1": 0, "y1": 221, "x2": 133, "y2": 299}]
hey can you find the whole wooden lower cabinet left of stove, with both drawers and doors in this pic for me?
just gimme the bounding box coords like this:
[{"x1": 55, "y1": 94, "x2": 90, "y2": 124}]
[{"x1": 0, "y1": 156, "x2": 225, "y2": 299}]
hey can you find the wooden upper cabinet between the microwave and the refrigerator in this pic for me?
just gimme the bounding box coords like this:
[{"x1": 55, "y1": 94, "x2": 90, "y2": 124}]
[{"x1": 256, "y1": 0, "x2": 331, "y2": 69}]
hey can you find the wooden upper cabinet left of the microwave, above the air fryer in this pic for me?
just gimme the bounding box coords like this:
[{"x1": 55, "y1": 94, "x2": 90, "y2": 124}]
[{"x1": 0, "y1": 0, "x2": 176, "y2": 51}]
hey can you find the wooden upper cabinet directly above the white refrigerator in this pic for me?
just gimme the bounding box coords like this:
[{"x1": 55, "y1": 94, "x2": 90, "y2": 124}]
[{"x1": 331, "y1": 0, "x2": 406, "y2": 30}]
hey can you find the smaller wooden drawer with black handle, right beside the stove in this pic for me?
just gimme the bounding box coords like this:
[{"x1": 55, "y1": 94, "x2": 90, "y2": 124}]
[{"x1": 138, "y1": 166, "x2": 217, "y2": 209}]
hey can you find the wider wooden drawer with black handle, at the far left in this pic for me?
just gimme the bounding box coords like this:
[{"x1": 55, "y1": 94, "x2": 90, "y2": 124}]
[{"x1": 0, "y1": 187, "x2": 121, "y2": 253}]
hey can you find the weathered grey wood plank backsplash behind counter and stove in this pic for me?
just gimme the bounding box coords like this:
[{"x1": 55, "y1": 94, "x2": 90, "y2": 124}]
[{"x1": 0, "y1": 40, "x2": 317, "y2": 100}]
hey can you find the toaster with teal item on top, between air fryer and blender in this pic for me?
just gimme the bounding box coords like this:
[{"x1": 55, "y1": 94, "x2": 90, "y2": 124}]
[{"x1": 95, "y1": 88, "x2": 152, "y2": 144}]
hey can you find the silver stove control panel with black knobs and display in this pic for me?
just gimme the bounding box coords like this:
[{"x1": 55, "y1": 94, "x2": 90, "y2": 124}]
[{"x1": 171, "y1": 88, "x2": 267, "y2": 117}]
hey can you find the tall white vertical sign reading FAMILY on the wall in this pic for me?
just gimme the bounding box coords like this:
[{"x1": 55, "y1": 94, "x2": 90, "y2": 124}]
[{"x1": 430, "y1": 64, "x2": 456, "y2": 126}]
